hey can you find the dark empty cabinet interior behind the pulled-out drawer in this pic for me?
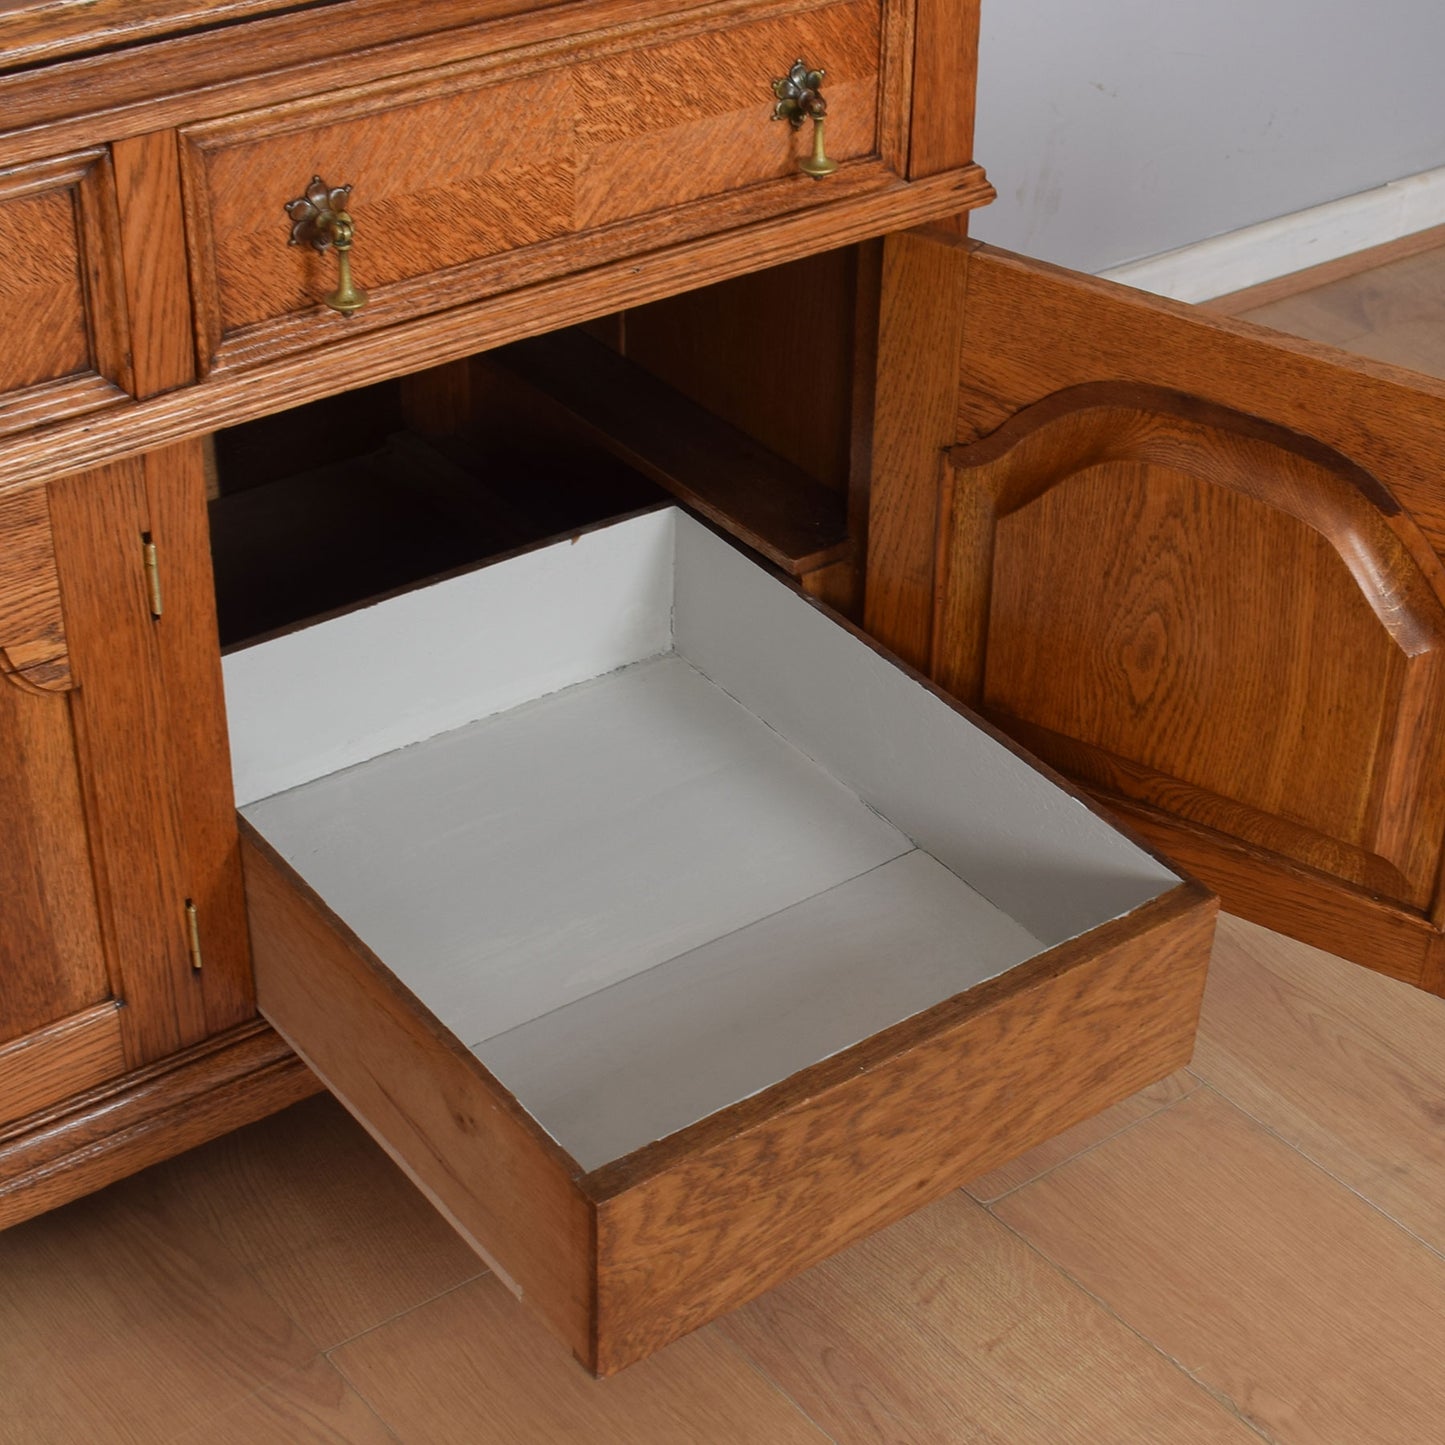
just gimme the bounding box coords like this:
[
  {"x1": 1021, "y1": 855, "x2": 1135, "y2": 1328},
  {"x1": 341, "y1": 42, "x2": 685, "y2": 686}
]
[{"x1": 208, "y1": 247, "x2": 873, "y2": 647}]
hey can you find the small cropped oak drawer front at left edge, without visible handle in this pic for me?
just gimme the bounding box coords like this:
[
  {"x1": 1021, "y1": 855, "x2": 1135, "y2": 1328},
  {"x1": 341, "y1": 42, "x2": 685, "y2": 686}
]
[{"x1": 0, "y1": 149, "x2": 129, "y2": 435}]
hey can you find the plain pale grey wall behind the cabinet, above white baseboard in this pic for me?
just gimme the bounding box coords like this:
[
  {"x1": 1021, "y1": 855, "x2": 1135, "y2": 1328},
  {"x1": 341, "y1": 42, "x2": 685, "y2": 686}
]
[{"x1": 970, "y1": 0, "x2": 1445, "y2": 272}]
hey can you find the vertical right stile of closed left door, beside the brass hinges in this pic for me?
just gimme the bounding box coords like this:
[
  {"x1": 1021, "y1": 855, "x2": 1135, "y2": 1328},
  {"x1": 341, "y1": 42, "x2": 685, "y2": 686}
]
[{"x1": 51, "y1": 461, "x2": 208, "y2": 1066}]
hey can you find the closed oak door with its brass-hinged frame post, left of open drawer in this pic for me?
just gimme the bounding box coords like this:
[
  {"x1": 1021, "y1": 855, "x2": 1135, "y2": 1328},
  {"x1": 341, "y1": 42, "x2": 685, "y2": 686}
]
[{"x1": 0, "y1": 447, "x2": 251, "y2": 1124}]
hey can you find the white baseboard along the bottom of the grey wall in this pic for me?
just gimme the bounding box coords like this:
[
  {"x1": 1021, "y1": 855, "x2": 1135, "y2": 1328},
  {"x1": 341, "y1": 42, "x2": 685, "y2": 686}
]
[{"x1": 1100, "y1": 166, "x2": 1445, "y2": 301}]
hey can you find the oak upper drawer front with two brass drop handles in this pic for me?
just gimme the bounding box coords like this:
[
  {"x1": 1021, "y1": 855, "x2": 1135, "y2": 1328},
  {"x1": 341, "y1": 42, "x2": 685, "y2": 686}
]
[{"x1": 182, "y1": 0, "x2": 903, "y2": 368}]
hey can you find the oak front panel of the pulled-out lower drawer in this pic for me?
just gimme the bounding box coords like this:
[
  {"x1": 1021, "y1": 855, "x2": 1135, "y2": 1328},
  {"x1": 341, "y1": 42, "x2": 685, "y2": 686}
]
[{"x1": 587, "y1": 884, "x2": 1214, "y2": 1374}]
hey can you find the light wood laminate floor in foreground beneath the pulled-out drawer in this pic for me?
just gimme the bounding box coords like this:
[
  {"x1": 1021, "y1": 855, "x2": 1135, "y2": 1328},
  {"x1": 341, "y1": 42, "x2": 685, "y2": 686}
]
[{"x1": 0, "y1": 919, "x2": 1445, "y2": 1445}]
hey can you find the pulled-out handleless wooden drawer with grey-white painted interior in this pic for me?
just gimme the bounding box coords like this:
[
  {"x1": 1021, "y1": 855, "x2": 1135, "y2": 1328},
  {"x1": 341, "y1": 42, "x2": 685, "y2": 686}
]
[{"x1": 225, "y1": 509, "x2": 1214, "y2": 1374}]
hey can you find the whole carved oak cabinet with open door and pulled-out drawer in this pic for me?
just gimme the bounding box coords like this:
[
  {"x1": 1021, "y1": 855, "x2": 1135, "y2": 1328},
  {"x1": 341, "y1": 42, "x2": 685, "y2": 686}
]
[{"x1": 0, "y1": 0, "x2": 1445, "y2": 1373}]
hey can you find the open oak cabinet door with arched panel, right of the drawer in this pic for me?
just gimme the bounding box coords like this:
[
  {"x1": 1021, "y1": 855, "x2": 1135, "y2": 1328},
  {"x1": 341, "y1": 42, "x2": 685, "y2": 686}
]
[{"x1": 868, "y1": 234, "x2": 1445, "y2": 993}]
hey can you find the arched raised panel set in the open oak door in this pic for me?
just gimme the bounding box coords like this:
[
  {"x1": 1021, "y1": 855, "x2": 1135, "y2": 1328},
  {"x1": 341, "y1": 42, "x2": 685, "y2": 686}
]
[{"x1": 935, "y1": 387, "x2": 1445, "y2": 909}]
